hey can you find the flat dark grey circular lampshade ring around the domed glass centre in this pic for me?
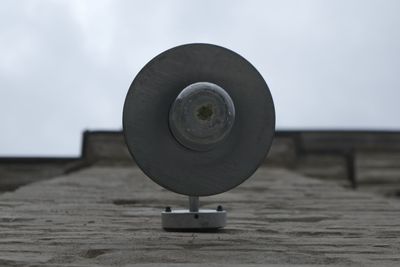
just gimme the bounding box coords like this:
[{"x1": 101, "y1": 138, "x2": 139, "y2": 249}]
[{"x1": 123, "y1": 44, "x2": 275, "y2": 196}]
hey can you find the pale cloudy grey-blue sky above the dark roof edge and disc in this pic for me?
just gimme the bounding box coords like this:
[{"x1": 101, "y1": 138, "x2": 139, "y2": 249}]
[{"x1": 0, "y1": 0, "x2": 400, "y2": 156}]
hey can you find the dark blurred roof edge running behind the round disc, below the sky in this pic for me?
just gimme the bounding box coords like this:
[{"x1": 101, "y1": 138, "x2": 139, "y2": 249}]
[{"x1": 0, "y1": 131, "x2": 400, "y2": 195}]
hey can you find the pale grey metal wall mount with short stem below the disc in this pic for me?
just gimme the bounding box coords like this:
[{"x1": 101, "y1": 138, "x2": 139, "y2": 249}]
[{"x1": 161, "y1": 196, "x2": 226, "y2": 231}]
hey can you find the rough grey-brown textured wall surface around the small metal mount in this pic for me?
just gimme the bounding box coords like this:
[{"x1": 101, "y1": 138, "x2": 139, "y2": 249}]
[{"x1": 0, "y1": 166, "x2": 400, "y2": 266}]
